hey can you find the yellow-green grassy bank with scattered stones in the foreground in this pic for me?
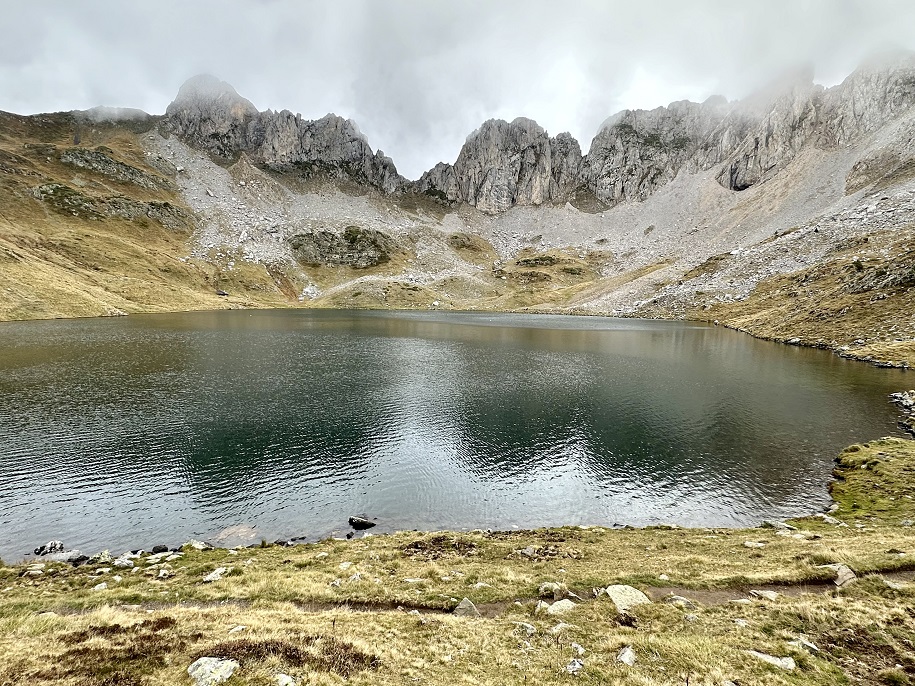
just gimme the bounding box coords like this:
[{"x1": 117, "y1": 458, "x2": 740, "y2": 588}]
[{"x1": 0, "y1": 439, "x2": 915, "y2": 685}]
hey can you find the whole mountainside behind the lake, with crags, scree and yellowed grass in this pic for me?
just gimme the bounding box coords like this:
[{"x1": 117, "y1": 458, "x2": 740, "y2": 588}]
[{"x1": 0, "y1": 55, "x2": 915, "y2": 365}]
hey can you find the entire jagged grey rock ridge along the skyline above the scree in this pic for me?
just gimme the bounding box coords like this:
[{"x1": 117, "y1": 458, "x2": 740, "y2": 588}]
[{"x1": 165, "y1": 54, "x2": 915, "y2": 214}]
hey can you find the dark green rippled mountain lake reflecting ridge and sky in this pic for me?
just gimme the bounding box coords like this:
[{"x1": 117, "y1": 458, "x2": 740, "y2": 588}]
[{"x1": 0, "y1": 310, "x2": 906, "y2": 559}]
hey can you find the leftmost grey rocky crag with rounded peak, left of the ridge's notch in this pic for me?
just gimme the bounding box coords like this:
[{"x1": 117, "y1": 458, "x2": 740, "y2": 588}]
[{"x1": 164, "y1": 76, "x2": 404, "y2": 193}]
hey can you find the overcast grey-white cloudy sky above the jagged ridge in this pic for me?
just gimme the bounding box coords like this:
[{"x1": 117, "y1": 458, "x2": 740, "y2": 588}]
[{"x1": 0, "y1": 0, "x2": 915, "y2": 178}]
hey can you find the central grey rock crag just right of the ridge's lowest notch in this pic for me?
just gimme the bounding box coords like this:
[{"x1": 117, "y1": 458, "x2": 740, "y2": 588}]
[{"x1": 416, "y1": 118, "x2": 582, "y2": 213}]
